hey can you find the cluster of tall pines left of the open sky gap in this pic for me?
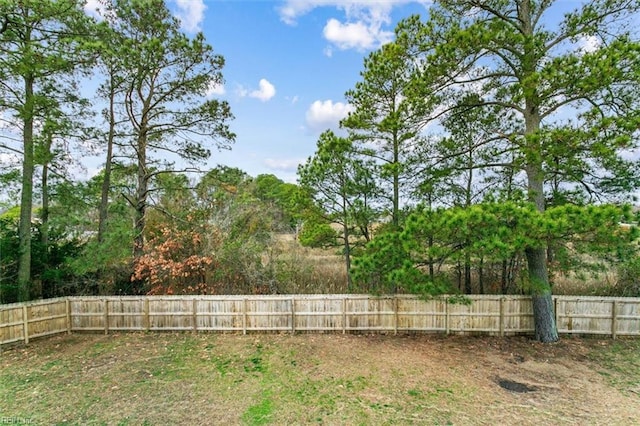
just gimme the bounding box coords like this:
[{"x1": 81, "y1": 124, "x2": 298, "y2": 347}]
[{"x1": 0, "y1": 0, "x2": 235, "y2": 300}]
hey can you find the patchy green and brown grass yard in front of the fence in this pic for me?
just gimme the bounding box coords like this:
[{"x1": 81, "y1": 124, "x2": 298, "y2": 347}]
[{"x1": 0, "y1": 334, "x2": 640, "y2": 425}]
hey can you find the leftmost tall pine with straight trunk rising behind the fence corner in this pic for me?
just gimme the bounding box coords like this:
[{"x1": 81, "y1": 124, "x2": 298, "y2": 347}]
[{"x1": 0, "y1": 0, "x2": 93, "y2": 300}]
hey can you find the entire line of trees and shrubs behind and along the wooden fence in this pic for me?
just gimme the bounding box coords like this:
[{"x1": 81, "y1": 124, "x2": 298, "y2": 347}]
[{"x1": 0, "y1": 0, "x2": 640, "y2": 341}]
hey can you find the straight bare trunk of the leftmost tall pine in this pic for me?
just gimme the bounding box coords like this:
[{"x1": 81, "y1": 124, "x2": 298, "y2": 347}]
[{"x1": 18, "y1": 76, "x2": 35, "y2": 302}]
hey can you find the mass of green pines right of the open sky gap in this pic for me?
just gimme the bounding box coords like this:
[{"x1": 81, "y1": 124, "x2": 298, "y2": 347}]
[{"x1": 300, "y1": 0, "x2": 640, "y2": 341}]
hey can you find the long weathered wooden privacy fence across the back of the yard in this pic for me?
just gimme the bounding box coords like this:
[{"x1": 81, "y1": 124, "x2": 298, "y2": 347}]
[{"x1": 0, "y1": 295, "x2": 640, "y2": 344}]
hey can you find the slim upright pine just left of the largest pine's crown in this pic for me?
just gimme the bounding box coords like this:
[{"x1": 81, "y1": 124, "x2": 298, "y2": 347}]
[{"x1": 341, "y1": 42, "x2": 433, "y2": 228}]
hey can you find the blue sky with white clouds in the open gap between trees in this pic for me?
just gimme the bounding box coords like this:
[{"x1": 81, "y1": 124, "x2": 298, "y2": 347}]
[{"x1": 82, "y1": 0, "x2": 428, "y2": 182}]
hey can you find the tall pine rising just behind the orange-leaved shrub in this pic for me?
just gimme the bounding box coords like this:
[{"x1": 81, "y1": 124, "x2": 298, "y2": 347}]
[{"x1": 109, "y1": 0, "x2": 235, "y2": 258}]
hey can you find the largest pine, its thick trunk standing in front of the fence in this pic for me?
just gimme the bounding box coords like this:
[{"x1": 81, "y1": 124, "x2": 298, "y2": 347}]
[{"x1": 404, "y1": 0, "x2": 640, "y2": 342}]
